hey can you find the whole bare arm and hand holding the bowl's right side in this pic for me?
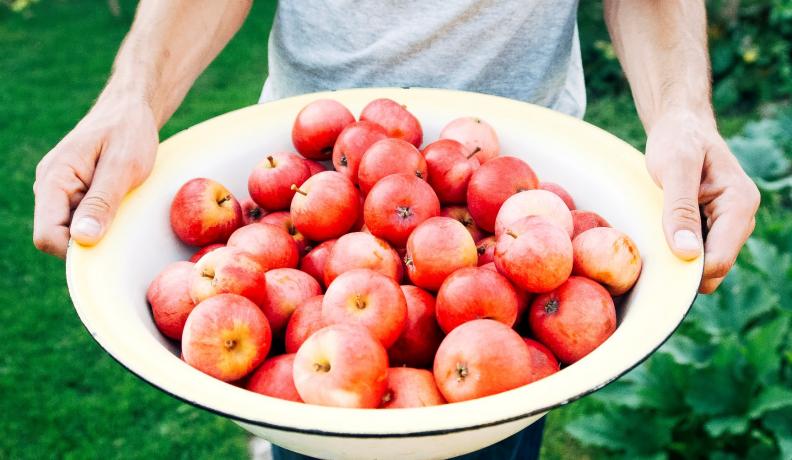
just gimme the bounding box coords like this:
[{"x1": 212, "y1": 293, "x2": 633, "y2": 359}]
[{"x1": 605, "y1": 0, "x2": 759, "y2": 293}]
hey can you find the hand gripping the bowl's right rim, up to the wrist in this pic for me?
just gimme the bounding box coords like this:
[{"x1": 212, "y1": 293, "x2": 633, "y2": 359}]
[{"x1": 646, "y1": 111, "x2": 760, "y2": 294}]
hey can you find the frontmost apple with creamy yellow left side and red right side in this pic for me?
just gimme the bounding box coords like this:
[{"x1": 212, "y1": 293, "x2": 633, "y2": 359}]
[{"x1": 293, "y1": 324, "x2": 388, "y2": 409}]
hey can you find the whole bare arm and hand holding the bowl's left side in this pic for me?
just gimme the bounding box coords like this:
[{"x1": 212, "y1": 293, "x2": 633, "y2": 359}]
[{"x1": 33, "y1": 0, "x2": 252, "y2": 257}]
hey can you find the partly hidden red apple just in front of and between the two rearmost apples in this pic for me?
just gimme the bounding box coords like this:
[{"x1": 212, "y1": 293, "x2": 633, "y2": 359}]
[{"x1": 333, "y1": 120, "x2": 388, "y2": 184}]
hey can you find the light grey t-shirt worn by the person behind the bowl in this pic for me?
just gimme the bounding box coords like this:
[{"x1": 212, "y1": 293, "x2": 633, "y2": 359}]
[{"x1": 261, "y1": 0, "x2": 586, "y2": 117}]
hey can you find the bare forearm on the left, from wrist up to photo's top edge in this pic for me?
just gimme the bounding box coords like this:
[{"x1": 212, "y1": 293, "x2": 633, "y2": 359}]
[{"x1": 100, "y1": 0, "x2": 252, "y2": 127}]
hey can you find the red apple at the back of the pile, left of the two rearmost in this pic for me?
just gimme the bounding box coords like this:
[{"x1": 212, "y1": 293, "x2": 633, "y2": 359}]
[{"x1": 292, "y1": 99, "x2": 355, "y2": 160}]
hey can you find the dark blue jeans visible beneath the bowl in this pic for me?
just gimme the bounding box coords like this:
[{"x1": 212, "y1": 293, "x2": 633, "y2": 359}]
[{"x1": 272, "y1": 417, "x2": 544, "y2": 460}]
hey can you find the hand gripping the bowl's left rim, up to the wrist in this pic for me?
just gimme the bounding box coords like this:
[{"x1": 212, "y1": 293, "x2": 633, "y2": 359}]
[{"x1": 33, "y1": 95, "x2": 158, "y2": 257}]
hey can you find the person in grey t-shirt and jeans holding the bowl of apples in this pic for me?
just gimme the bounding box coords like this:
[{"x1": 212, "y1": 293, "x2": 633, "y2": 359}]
[{"x1": 33, "y1": 0, "x2": 759, "y2": 458}]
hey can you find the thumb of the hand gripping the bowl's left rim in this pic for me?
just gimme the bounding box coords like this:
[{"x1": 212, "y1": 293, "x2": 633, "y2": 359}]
[{"x1": 69, "y1": 159, "x2": 128, "y2": 246}]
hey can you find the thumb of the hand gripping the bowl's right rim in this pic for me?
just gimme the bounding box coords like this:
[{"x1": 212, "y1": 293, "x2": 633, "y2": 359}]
[{"x1": 660, "y1": 159, "x2": 703, "y2": 260}]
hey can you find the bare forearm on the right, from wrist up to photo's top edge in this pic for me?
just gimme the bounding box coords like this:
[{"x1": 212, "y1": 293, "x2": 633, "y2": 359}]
[{"x1": 605, "y1": 0, "x2": 714, "y2": 132}]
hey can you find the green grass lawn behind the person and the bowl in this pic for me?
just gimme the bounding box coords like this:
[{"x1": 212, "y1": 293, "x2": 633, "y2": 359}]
[{"x1": 0, "y1": 0, "x2": 743, "y2": 459}]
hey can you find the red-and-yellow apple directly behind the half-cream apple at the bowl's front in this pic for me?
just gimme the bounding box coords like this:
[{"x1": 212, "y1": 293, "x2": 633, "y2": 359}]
[{"x1": 322, "y1": 268, "x2": 407, "y2": 348}]
